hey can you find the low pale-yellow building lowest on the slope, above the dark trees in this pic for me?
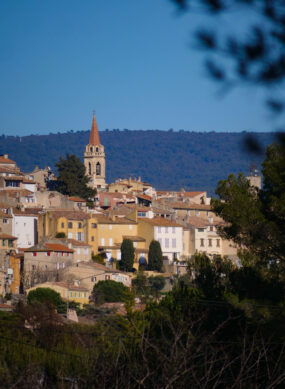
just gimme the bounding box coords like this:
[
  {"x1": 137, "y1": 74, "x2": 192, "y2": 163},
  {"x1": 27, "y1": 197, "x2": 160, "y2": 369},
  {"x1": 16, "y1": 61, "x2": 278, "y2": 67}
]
[{"x1": 27, "y1": 282, "x2": 90, "y2": 306}]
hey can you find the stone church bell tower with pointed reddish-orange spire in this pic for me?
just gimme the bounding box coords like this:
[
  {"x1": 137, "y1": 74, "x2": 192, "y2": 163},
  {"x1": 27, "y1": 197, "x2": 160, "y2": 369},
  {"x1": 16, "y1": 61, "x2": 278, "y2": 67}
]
[{"x1": 84, "y1": 113, "x2": 106, "y2": 190}]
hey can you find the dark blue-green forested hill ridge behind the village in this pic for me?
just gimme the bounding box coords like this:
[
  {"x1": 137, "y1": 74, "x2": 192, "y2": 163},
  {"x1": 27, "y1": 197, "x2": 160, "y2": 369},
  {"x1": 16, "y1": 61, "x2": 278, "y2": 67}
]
[{"x1": 0, "y1": 130, "x2": 273, "y2": 193}]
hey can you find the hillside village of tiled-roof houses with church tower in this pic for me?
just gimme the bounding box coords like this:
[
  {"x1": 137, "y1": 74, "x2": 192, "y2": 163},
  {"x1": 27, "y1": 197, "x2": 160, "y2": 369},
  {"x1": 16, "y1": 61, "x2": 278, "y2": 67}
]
[{"x1": 0, "y1": 114, "x2": 254, "y2": 305}]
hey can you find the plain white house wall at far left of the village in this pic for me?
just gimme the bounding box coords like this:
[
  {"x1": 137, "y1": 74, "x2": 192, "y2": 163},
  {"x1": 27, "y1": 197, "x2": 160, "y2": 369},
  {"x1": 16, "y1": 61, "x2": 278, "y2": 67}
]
[{"x1": 12, "y1": 215, "x2": 38, "y2": 248}]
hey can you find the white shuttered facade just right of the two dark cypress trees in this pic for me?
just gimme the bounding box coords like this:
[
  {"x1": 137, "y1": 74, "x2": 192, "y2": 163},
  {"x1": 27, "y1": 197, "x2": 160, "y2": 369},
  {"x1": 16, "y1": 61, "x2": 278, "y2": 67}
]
[{"x1": 154, "y1": 226, "x2": 183, "y2": 261}]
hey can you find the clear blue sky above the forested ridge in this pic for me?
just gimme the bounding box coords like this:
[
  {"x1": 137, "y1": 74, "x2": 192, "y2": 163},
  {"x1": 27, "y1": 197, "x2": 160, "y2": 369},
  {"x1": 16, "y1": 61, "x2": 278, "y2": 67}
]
[{"x1": 0, "y1": 0, "x2": 278, "y2": 135}]
